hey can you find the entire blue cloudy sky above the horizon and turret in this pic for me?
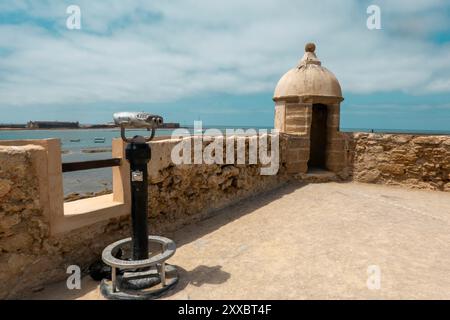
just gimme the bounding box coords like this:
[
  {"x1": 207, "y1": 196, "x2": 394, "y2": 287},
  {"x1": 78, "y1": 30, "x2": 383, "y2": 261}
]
[{"x1": 0, "y1": 0, "x2": 450, "y2": 130}]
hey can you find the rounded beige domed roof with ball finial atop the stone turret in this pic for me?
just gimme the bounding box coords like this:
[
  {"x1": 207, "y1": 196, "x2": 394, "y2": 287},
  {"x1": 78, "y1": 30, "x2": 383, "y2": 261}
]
[{"x1": 273, "y1": 43, "x2": 343, "y2": 101}]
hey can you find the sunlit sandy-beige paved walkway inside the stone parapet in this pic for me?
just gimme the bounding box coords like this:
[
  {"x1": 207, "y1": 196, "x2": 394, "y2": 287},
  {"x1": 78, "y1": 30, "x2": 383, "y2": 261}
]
[{"x1": 29, "y1": 183, "x2": 450, "y2": 299}]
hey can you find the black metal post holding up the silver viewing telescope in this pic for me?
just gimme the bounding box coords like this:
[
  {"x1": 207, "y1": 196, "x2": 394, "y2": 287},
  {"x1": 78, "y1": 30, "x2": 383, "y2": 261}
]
[{"x1": 125, "y1": 136, "x2": 151, "y2": 260}]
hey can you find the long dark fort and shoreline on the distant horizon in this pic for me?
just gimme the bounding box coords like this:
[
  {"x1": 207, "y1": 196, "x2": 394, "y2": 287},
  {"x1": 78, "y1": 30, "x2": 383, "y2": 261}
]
[{"x1": 0, "y1": 121, "x2": 180, "y2": 129}]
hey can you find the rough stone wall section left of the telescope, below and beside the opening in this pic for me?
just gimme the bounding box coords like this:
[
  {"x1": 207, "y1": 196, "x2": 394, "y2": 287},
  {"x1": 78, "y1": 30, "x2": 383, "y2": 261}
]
[{"x1": 0, "y1": 145, "x2": 132, "y2": 299}]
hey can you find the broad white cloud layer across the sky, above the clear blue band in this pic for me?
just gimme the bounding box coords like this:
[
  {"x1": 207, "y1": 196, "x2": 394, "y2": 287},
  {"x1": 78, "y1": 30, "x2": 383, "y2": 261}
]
[{"x1": 0, "y1": 0, "x2": 450, "y2": 106}]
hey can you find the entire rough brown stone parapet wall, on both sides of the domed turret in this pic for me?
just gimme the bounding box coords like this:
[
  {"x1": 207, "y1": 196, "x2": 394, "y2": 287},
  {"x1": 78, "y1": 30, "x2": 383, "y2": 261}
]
[{"x1": 0, "y1": 133, "x2": 450, "y2": 299}]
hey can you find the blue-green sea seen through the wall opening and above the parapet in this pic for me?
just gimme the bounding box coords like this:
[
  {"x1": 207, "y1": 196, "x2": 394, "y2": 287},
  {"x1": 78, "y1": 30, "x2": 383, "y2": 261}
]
[{"x1": 0, "y1": 126, "x2": 450, "y2": 195}]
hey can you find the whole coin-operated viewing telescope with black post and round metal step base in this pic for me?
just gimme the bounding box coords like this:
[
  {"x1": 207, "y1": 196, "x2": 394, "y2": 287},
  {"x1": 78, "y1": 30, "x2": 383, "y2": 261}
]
[{"x1": 100, "y1": 112, "x2": 178, "y2": 299}]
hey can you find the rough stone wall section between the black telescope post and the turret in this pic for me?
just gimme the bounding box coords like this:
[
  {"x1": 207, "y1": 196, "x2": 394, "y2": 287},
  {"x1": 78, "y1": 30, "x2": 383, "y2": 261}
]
[{"x1": 149, "y1": 135, "x2": 295, "y2": 230}]
